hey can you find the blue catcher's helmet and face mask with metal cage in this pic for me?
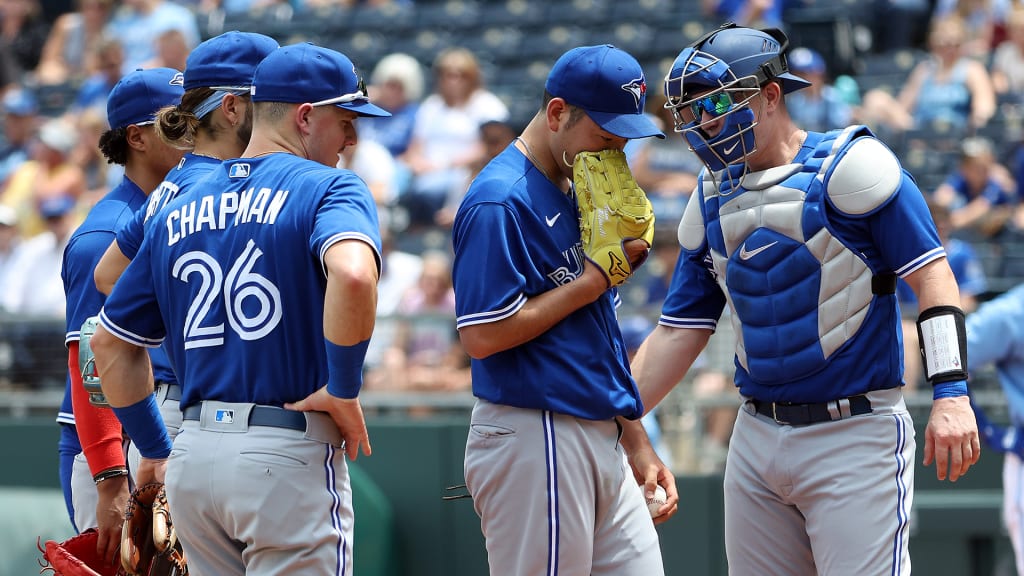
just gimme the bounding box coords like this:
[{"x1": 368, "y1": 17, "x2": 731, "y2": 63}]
[{"x1": 665, "y1": 23, "x2": 810, "y2": 171}]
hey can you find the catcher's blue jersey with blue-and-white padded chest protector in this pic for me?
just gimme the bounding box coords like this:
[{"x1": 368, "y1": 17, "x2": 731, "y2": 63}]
[{"x1": 659, "y1": 127, "x2": 944, "y2": 403}]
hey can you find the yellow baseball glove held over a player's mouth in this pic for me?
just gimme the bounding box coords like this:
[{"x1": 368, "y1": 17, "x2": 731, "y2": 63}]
[{"x1": 572, "y1": 145, "x2": 654, "y2": 286}]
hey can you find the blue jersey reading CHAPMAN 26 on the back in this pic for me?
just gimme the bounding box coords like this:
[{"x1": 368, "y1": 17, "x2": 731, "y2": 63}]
[{"x1": 100, "y1": 154, "x2": 380, "y2": 409}]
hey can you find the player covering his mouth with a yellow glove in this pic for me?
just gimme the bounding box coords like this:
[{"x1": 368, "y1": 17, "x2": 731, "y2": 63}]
[{"x1": 453, "y1": 45, "x2": 678, "y2": 576}]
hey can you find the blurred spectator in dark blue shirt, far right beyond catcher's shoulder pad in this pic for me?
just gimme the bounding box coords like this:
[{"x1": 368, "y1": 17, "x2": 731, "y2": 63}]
[{"x1": 932, "y1": 136, "x2": 1018, "y2": 238}]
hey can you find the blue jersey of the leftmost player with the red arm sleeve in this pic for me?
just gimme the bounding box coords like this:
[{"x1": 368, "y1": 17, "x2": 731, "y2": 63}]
[{"x1": 57, "y1": 178, "x2": 174, "y2": 423}]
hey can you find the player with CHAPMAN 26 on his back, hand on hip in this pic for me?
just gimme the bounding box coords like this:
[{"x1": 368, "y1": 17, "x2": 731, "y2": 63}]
[{"x1": 93, "y1": 44, "x2": 388, "y2": 575}]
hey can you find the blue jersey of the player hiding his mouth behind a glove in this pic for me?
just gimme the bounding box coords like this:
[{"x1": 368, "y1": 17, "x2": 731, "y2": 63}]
[{"x1": 453, "y1": 146, "x2": 643, "y2": 420}]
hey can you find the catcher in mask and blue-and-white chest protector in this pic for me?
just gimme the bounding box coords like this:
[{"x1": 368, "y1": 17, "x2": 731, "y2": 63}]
[{"x1": 633, "y1": 24, "x2": 980, "y2": 575}]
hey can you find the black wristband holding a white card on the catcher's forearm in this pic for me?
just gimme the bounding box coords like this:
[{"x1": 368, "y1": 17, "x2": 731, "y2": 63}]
[{"x1": 918, "y1": 305, "x2": 967, "y2": 386}]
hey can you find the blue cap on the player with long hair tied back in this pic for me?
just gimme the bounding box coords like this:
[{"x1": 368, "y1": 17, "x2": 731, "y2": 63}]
[{"x1": 183, "y1": 30, "x2": 278, "y2": 91}]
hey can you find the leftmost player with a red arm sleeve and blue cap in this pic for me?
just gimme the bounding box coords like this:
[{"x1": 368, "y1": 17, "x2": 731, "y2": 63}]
[{"x1": 58, "y1": 68, "x2": 182, "y2": 559}]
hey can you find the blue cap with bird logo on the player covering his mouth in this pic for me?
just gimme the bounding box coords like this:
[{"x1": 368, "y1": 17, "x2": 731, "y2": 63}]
[{"x1": 544, "y1": 44, "x2": 665, "y2": 138}]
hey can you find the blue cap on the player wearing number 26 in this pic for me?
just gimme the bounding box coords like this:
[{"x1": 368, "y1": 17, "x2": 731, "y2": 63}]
[{"x1": 252, "y1": 42, "x2": 391, "y2": 117}]
